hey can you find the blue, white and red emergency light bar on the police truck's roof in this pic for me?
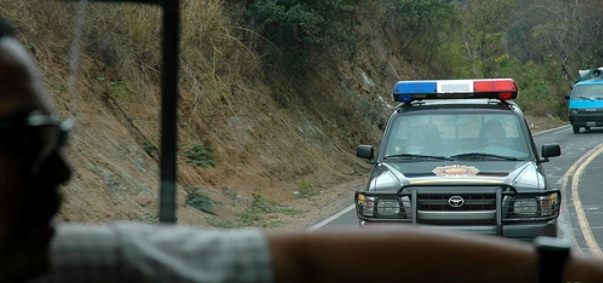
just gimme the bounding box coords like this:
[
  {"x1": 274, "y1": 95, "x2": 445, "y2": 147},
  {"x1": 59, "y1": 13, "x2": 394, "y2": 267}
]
[{"x1": 392, "y1": 79, "x2": 519, "y2": 102}]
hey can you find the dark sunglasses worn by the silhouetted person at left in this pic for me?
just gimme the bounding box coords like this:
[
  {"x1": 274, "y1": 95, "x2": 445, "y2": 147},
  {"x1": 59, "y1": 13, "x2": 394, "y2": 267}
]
[{"x1": 0, "y1": 110, "x2": 74, "y2": 168}]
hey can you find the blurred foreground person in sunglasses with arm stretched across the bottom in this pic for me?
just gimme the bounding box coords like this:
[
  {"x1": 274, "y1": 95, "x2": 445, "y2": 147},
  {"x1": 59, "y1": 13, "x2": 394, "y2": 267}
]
[{"x1": 0, "y1": 15, "x2": 603, "y2": 283}]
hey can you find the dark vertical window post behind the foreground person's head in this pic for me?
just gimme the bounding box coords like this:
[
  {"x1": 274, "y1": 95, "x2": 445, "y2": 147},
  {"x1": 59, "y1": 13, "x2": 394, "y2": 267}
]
[{"x1": 159, "y1": 0, "x2": 180, "y2": 223}]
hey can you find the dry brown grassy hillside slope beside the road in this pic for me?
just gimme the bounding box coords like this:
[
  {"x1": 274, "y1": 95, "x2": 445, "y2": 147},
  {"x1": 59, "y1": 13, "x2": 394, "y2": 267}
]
[{"x1": 0, "y1": 0, "x2": 568, "y2": 229}]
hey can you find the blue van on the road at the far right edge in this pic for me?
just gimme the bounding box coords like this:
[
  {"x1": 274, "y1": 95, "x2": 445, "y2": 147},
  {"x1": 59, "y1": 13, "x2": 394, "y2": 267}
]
[{"x1": 566, "y1": 67, "x2": 603, "y2": 134}]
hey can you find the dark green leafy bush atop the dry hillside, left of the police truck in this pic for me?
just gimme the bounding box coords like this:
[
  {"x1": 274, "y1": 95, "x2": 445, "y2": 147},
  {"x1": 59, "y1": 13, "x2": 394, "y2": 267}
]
[{"x1": 235, "y1": 0, "x2": 358, "y2": 71}]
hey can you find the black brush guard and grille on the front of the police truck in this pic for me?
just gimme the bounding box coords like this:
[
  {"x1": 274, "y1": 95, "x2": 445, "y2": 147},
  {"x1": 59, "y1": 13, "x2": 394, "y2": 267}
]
[{"x1": 354, "y1": 184, "x2": 561, "y2": 236}]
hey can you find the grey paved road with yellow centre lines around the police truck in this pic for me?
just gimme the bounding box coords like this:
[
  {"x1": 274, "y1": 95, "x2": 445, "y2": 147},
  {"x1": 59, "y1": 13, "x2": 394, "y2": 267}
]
[{"x1": 310, "y1": 126, "x2": 603, "y2": 257}]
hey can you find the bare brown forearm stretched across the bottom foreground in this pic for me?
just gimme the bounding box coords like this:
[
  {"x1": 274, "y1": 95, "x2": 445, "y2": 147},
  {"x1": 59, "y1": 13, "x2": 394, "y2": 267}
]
[{"x1": 268, "y1": 227, "x2": 603, "y2": 283}]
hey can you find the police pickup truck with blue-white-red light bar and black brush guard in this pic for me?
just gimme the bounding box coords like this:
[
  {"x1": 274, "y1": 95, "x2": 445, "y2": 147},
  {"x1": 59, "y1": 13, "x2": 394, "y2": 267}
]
[{"x1": 355, "y1": 79, "x2": 561, "y2": 240}]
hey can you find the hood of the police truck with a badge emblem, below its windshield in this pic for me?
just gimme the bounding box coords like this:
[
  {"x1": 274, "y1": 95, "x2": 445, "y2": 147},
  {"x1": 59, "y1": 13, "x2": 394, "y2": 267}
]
[{"x1": 367, "y1": 161, "x2": 546, "y2": 192}]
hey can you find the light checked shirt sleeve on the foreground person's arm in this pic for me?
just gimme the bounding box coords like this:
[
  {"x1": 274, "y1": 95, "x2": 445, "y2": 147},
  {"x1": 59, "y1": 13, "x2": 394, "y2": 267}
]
[{"x1": 28, "y1": 223, "x2": 274, "y2": 283}]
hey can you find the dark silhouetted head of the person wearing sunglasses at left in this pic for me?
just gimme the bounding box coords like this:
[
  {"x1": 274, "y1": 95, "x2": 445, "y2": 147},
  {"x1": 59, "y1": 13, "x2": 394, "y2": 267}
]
[{"x1": 0, "y1": 18, "x2": 71, "y2": 282}]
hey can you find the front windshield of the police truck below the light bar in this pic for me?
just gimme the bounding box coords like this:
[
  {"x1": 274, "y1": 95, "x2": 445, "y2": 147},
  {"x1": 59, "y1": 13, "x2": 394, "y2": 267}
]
[{"x1": 384, "y1": 111, "x2": 530, "y2": 161}]
